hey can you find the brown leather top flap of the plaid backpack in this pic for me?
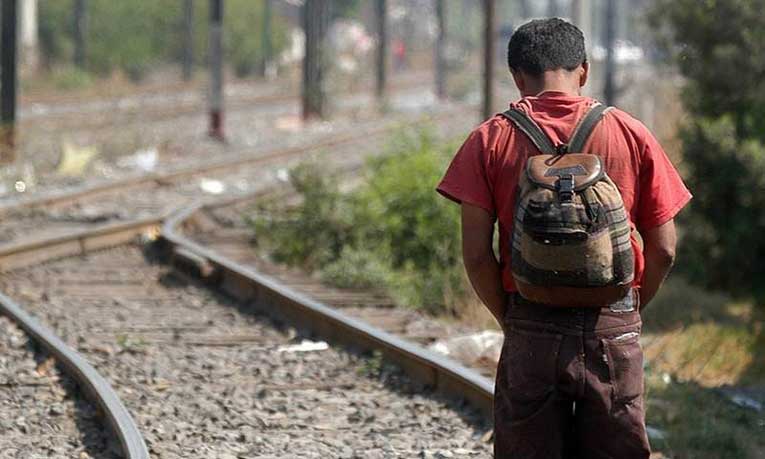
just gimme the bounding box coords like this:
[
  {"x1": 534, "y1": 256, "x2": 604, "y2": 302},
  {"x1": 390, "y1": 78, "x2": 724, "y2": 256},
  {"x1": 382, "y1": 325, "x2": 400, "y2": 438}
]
[{"x1": 526, "y1": 153, "x2": 604, "y2": 192}]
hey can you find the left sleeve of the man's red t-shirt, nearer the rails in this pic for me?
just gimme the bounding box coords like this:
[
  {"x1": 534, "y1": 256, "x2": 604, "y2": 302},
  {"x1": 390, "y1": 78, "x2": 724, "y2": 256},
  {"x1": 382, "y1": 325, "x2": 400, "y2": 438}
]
[{"x1": 436, "y1": 131, "x2": 496, "y2": 215}]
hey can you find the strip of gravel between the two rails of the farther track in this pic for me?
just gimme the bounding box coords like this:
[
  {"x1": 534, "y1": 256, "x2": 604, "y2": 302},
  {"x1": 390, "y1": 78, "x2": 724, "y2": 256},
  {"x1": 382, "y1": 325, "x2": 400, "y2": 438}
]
[{"x1": 0, "y1": 108, "x2": 466, "y2": 252}]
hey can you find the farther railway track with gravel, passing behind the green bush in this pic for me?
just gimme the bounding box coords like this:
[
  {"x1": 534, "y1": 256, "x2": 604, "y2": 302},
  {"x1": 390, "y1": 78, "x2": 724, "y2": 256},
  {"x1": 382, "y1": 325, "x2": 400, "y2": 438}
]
[{"x1": 0, "y1": 108, "x2": 472, "y2": 271}]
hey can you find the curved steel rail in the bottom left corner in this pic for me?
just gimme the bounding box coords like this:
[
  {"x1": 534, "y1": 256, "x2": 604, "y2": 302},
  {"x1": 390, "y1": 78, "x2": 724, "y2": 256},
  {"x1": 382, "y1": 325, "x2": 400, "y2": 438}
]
[{"x1": 0, "y1": 293, "x2": 149, "y2": 459}]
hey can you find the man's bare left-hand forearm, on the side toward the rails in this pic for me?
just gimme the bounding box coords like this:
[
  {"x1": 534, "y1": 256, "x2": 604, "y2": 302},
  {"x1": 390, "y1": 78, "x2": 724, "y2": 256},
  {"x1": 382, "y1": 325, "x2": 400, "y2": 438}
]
[{"x1": 462, "y1": 202, "x2": 507, "y2": 327}]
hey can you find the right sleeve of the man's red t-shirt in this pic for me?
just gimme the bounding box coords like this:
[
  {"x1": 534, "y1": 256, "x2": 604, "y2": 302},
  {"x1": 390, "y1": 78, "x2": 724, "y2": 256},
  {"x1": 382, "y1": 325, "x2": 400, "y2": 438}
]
[{"x1": 635, "y1": 128, "x2": 691, "y2": 230}]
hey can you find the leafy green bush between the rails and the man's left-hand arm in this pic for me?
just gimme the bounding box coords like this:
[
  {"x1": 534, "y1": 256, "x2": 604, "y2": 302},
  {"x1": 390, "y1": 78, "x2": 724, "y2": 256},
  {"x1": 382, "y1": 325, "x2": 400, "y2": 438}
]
[{"x1": 252, "y1": 130, "x2": 464, "y2": 312}]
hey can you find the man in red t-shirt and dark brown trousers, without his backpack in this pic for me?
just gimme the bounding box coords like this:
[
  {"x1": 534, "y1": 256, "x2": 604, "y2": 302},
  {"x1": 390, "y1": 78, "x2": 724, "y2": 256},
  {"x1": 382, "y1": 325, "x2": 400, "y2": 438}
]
[{"x1": 438, "y1": 19, "x2": 691, "y2": 459}]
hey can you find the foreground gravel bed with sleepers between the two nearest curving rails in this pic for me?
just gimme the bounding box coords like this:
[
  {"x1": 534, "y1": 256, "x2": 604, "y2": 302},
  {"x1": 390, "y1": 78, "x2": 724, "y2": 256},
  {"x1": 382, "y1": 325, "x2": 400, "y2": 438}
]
[{"x1": 0, "y1": 246, "x2": 491, "y2": 458}]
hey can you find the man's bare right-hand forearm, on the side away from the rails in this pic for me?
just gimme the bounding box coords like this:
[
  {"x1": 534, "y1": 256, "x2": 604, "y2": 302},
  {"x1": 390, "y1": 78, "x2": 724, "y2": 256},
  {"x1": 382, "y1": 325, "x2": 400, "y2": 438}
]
[{"x1": 640, "y1": 220, "x2": 677, "y2": 310}]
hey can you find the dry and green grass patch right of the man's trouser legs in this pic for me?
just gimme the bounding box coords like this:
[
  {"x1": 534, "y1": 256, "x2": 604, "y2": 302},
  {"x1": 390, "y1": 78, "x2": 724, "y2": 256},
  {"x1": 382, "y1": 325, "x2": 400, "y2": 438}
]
[{"x1": 643, "y1": 279, "x2": 765, "y2": 459}]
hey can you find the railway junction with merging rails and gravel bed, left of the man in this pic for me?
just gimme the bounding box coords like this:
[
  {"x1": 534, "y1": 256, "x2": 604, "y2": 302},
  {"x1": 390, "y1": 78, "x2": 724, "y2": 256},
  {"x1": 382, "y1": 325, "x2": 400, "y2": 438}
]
[{"x1": 0, "y1": 88, "x2": 492, "y2": 459}]
